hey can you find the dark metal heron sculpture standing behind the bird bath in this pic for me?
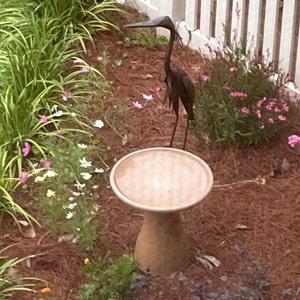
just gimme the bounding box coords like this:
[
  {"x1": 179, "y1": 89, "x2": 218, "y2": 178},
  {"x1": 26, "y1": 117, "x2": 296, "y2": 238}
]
[{"x1": 125, "y1": 16, "x2": 195, "y2": 149}]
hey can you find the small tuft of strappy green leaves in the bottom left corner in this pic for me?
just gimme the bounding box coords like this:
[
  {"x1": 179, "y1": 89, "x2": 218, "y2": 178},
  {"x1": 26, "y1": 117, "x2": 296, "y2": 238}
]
[{"x1": 0, "y1": 247, "x2": 38, "y2": 300}]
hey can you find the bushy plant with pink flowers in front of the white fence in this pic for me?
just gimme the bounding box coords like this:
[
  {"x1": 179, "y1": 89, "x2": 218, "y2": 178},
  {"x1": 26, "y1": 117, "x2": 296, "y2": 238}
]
[{"x1": 195, "y1": 47, "x2": 291, "y2": 146}]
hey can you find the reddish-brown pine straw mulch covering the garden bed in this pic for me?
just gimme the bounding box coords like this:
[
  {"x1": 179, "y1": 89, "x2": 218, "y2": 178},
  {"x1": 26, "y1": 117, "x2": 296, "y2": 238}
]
[{"x1": 2, "y1": 5, "x2": 300, "y2": 300}]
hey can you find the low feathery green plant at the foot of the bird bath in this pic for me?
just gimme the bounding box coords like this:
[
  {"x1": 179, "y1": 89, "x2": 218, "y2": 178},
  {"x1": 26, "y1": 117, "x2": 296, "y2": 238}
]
[{"x1": 77, "y1": 254, "x2": 140, "y2": 300}]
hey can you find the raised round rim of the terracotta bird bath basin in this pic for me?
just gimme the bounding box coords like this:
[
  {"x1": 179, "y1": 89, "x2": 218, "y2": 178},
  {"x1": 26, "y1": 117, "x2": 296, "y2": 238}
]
[{"x1": 110, "y1": 147, "x2": 213, "y2": 213}]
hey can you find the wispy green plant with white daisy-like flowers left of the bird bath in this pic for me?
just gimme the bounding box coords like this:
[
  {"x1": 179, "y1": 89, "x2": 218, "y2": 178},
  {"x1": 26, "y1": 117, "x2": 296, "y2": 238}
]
[{"x1": 32, "y1": 138, "x2": 107, "y2": 250}]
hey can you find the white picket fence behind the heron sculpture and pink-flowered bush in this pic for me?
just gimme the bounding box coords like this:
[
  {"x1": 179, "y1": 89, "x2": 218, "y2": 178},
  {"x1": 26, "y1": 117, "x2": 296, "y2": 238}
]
[{"x1": 126, "y1": 0, "x2": 300, "y2": 90}]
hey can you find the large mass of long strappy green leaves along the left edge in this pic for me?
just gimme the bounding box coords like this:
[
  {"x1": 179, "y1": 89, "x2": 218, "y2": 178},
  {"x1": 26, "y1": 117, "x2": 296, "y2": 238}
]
[{"x1": 0, "y1": 0, "x2": 124, "y2": 226}]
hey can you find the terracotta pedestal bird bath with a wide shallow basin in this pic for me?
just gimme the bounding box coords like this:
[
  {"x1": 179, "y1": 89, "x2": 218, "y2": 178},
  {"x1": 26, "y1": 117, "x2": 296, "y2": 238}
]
[{"x1": 110, "y1": 148, "x2": 213, "y2": 274}]
